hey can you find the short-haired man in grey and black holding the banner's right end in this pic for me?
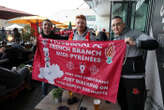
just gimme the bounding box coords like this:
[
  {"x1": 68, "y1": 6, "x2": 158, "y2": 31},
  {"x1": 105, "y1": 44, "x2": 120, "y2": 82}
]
[{"x1": 112, "y1": 16, "x2": 158, "y2": 110}]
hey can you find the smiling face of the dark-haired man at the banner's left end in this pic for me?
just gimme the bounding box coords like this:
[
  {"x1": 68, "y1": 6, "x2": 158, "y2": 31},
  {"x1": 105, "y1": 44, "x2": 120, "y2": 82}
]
[{"x1": 42, "y1": 21, "x2": 52, "y2": 35}]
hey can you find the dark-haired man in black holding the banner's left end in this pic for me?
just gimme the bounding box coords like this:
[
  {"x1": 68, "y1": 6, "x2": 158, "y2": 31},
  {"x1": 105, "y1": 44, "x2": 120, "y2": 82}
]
[{"x1": 40, "y1": 19, "x2": 64, "y2": 96}]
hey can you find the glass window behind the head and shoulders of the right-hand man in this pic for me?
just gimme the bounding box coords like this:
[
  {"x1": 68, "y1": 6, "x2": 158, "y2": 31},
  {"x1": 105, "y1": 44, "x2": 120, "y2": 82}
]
[{"x1": 112, "y1": 1, "x2": 148, "y2": 31}]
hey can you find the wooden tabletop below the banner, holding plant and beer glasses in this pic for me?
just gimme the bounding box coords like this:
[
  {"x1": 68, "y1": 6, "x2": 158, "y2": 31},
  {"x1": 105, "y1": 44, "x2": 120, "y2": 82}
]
[{"x1": 34, "y1": 91, "x2": 120, "y2": 110}]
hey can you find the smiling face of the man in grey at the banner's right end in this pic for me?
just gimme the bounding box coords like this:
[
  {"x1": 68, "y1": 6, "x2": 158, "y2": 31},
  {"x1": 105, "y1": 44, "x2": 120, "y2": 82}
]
[{"x1": 112, "y1": 18, "x2": 125, "y2": 35}]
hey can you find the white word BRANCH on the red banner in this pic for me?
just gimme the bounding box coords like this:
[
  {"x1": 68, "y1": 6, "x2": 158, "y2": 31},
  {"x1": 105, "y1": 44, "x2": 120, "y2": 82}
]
[{"x1": 72, "y1": 48, "x2": 102, "y2": 56}]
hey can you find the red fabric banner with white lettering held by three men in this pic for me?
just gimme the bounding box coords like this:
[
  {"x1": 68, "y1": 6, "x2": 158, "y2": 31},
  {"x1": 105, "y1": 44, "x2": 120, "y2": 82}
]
[{"x1": 32, "y1": 37, "x2": 126, "y2": 103}]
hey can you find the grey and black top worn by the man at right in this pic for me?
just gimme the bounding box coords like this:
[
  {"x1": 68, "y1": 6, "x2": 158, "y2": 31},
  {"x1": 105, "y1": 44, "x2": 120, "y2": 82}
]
[{"x1": 114, "y1": 27, "x2": 158, "y2": 78}]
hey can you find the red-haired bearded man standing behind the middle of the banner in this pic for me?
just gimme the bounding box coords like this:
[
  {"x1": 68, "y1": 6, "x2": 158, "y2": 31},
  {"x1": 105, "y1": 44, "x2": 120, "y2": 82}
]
[{"x1": 69, "y1": 15, "x2": 95, "y2": 41}]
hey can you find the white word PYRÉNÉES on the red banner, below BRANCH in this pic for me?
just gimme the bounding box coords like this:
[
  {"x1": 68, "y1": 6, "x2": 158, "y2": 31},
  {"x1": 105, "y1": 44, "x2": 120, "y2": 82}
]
[{"x1": 70, "y1": 54, "x2": 101, "y2": 63}]
